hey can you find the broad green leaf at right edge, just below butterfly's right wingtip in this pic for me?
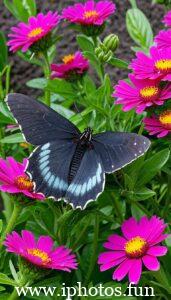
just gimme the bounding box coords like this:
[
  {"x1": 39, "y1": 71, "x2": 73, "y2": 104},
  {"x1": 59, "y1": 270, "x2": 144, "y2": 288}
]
[{"x1": 136, "y1": 149, "x2": 170, "y2": 186}]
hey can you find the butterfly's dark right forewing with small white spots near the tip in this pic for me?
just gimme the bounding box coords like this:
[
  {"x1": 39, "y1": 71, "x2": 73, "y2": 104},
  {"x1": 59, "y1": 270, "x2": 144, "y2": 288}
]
[{"x1": 92, "y1": 132, "x2": 150, "y2": 173}]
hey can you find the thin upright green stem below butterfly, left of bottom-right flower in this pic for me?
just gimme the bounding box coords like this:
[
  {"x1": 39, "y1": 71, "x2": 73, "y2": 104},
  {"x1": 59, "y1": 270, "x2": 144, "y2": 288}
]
[{"x1": 85, "y1": 214, "x2": 99, "y2": 285}]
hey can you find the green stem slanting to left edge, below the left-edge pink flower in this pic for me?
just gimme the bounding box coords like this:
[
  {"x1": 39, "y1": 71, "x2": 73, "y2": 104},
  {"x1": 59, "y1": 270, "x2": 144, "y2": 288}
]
[{"x1": 0, "y1": 203, "x2": 22, "y2": 250}]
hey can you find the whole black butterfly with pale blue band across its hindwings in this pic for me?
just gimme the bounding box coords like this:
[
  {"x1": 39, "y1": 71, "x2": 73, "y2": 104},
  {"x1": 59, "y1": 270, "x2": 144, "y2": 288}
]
[{"x1": 7, "y1": 94, "x2": 150, "y2": 208}]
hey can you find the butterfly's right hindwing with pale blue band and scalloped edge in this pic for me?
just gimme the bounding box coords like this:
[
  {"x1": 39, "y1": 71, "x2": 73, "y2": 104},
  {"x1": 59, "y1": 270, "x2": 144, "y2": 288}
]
[{"x1": 65, "y1": 149, "x2": 105, "y2": 208}]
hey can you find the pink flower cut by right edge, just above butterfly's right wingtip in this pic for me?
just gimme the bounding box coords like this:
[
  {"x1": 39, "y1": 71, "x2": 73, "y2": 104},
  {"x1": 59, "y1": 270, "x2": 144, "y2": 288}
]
[{"x1": 143, "y1": 110, "x2": 171, "y2": 138}]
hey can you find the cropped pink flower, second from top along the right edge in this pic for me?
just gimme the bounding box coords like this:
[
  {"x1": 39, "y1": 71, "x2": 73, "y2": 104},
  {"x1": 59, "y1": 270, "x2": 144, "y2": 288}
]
[{"x1": 154, "y1": 29, "x2": 171, "y2": 49}]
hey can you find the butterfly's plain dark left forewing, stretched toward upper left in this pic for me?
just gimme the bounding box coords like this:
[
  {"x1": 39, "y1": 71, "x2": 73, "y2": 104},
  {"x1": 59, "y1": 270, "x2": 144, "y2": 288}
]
[{"x1": 7, "y1": 94, "x2": 80, "y2": 146}]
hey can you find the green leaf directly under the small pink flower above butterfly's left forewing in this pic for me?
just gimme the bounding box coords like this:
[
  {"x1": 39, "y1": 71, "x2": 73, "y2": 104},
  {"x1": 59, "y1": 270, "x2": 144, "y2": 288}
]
[{"x1": 46, "y1": 79, "x2": 75, "y2": 98}]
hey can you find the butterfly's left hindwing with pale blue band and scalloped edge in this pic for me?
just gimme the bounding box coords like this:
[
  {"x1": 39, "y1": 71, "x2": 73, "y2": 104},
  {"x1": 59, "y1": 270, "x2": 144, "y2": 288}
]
[{"x1": 27, "y1": 140, "x2": 76, "y2": 199}]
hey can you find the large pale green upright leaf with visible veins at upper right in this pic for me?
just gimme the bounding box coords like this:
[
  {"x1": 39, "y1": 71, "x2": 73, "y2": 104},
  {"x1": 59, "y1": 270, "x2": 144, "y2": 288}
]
[{"x1": 126, "y1": 8, "x2": 153, "y2": 50}]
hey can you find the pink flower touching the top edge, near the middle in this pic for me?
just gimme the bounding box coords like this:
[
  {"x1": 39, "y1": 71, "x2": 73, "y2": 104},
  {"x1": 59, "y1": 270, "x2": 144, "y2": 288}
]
[{"x1": 62, "y1": 0, "x2": 116, "y2": 26}]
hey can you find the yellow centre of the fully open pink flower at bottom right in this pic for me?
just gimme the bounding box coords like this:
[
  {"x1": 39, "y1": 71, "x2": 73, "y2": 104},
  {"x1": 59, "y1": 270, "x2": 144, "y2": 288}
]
[{"x1": 125, "y1": 236, "x2": 148, "y2": 258}]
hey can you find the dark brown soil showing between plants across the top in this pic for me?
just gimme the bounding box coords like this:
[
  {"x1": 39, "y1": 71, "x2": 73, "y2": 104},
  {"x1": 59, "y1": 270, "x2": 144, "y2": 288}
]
[{"x1": 0, "y1": 0, "x2": 164, "y2": 94}]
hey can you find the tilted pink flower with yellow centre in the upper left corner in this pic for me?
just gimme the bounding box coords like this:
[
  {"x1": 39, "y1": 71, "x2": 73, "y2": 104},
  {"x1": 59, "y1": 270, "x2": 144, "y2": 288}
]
[{"x1": 7, "y1": 11, "x2": 60, "y2": 52}]
